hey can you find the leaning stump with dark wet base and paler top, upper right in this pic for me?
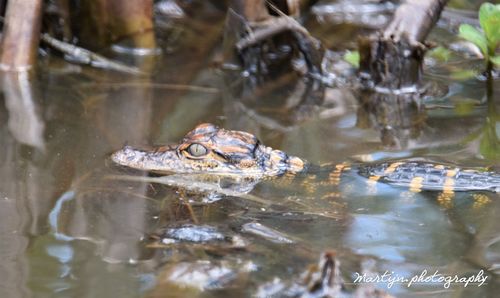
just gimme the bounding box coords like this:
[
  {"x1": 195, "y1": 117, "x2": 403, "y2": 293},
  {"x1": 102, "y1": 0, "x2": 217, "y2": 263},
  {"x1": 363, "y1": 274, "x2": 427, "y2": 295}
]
[{"x1": 359, "y1": 0, "x2": 448, "y2": 89}]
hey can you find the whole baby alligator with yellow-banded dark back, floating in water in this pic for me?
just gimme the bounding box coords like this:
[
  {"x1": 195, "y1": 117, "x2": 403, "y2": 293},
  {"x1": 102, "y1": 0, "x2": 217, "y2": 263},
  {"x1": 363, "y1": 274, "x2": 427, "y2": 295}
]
[{"x1": 111, "y1": 124, "x2": 500, "y2": 194}]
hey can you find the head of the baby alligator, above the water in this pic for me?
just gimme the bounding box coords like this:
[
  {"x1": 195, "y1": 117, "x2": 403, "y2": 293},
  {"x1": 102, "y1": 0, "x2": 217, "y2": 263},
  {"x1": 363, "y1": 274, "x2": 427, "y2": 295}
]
[{"x1": 111, "y1": 123, "x2": 305, "y2": 177}]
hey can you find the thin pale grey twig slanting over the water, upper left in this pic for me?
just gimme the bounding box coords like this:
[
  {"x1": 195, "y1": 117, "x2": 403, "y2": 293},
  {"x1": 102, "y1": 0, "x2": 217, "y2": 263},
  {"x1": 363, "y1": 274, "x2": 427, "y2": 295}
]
[{"x1": 41, "y1": 33, "x2": 144, "y2": 75}]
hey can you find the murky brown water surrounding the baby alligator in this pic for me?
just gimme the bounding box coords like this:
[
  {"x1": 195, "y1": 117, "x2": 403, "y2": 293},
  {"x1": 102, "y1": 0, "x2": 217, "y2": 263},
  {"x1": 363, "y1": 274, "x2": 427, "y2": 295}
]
[{"x1": 0, "y1": 0, "x2": 500, "y2": 297}]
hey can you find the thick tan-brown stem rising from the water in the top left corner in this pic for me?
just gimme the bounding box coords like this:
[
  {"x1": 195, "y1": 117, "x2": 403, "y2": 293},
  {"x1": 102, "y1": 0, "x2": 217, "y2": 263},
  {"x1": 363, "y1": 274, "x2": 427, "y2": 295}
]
[{"x1": 0, "y1": 0, "x2": 42, "y2": 71}]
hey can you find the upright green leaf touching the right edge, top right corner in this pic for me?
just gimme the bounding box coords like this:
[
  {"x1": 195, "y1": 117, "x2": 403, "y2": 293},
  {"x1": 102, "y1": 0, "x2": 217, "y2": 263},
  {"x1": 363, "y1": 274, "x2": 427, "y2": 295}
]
[{"x1": 479, "y1": 3, "x2": 500, "y2": 54}]
